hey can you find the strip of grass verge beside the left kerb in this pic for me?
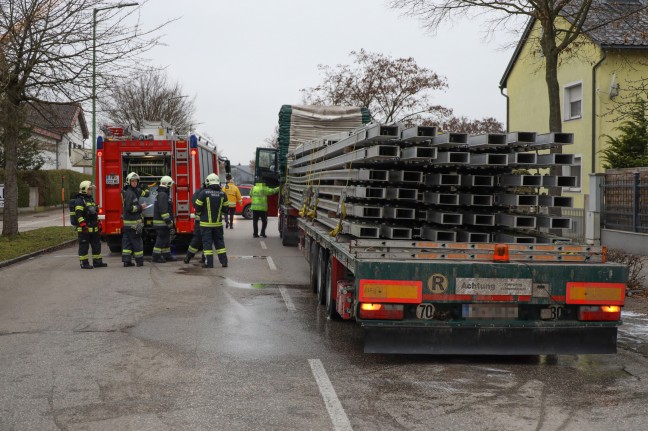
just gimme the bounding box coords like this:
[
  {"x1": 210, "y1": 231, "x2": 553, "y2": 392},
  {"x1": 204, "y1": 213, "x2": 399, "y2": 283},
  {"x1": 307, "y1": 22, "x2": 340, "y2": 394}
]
[{"x1": 0, "y1": 226, "x2": 77, "y2": 262}]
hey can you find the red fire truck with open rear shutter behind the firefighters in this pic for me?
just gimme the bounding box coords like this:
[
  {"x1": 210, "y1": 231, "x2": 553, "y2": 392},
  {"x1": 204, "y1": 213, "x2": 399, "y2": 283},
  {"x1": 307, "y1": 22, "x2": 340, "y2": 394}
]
[{"x1": 95, "y1": 122, "x2": 230, "y2": 252}]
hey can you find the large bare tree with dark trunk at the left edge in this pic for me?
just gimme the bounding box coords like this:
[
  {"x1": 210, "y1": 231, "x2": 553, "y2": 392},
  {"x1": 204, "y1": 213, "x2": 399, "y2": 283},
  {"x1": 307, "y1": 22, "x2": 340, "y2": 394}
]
[{"x1": 0, "y1": 0, "x2": 164, "y2": 235}]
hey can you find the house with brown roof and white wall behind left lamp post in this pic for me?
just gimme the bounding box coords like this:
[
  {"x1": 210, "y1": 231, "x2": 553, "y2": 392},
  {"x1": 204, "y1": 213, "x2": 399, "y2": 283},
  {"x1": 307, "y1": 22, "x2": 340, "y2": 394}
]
[{"x1": 25, "y1": 103, "x2": 92, "y2": 173}]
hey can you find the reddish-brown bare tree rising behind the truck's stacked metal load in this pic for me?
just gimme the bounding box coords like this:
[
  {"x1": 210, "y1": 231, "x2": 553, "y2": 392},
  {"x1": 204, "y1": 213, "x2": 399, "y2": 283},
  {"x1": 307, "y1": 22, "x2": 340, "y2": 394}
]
[{"x1": 300, "y1": 49, "x2": 452, "y2": 123}]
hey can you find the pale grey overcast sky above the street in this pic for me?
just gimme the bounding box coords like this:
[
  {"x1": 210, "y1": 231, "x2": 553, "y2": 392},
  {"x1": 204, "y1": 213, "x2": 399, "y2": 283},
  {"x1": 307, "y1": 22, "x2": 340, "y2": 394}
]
[{"x1": 134, "y1": 0, "x2": 512, "y2": 165}]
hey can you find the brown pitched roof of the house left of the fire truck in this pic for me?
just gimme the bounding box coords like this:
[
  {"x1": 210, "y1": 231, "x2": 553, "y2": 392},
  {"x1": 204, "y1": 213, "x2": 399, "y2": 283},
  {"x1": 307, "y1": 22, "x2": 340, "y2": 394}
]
[{"x1": 25, "y1": 103, "x2": 90, "y2": 139}]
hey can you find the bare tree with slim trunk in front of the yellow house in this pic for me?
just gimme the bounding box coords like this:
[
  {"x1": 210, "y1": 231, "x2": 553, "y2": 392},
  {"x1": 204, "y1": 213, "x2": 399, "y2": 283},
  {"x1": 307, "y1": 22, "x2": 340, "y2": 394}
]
[{"x1": 390, "y1": 0, "x2": 646, "y2": 132}]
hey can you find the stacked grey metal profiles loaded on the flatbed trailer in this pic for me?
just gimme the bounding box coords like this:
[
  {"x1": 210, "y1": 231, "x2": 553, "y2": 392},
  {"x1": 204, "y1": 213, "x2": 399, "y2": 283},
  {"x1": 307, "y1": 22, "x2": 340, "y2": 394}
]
[{"x1": 285, "y1": 124, "x2": 576, "y2": 244}]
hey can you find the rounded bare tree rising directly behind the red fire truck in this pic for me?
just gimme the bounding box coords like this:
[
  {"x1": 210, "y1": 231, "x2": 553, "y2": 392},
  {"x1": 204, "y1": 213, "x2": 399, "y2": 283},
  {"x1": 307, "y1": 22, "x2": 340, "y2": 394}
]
[{"x1": 101, "y1": 69, "x2": 196, "y2": 132}]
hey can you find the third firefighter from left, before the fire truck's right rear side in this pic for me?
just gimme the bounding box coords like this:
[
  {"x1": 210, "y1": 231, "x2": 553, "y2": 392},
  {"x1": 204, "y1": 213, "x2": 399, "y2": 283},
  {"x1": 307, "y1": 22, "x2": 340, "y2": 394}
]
[{"x1": 153, "y1": 176, "x2": 178, "y2": 263}]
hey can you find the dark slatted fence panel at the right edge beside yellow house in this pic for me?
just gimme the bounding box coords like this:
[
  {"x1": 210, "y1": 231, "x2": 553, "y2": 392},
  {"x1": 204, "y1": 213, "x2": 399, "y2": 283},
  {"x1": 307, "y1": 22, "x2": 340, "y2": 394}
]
[{"x1": 601, "y1": 168, "x2": 648, "y2": 233}]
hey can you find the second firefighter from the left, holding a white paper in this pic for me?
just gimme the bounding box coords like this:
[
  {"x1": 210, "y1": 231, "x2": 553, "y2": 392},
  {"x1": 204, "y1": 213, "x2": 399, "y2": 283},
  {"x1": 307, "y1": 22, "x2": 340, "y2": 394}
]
[{"x1": 122, "y1": 172, "x2": 148, "y2": 267}]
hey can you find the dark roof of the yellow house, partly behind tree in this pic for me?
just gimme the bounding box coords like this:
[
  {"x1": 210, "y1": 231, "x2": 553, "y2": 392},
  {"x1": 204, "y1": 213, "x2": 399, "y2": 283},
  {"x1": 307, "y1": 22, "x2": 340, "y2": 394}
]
[{"x1": 500, "y1": 0, "x2": 648, "y2": 88}]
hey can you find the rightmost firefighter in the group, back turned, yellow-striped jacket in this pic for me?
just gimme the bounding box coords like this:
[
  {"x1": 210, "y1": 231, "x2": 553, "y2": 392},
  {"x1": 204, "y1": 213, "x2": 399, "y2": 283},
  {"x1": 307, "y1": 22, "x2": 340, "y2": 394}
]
[{"x1": 196, "y1": 174, "x2": 227, "y2": 268}]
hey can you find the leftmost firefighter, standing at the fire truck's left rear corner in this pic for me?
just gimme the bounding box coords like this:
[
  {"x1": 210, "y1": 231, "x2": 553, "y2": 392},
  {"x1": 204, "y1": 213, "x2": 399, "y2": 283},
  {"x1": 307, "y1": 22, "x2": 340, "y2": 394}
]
[{"x1": 74, "y1": 181, "x2": 108, "y2": 269}]
